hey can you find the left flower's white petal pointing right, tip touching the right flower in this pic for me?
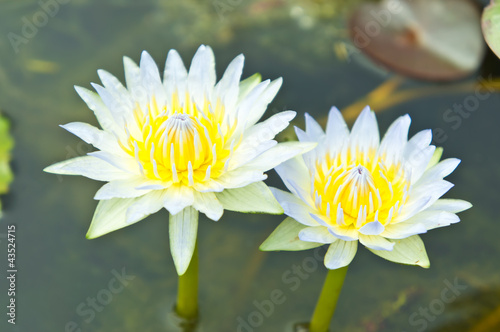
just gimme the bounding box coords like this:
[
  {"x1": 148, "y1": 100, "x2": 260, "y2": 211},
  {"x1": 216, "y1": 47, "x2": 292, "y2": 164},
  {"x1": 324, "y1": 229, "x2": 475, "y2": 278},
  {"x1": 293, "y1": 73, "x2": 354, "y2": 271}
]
[{"x1": 245, "y1": 142, "x2": 316, "y2": 172}]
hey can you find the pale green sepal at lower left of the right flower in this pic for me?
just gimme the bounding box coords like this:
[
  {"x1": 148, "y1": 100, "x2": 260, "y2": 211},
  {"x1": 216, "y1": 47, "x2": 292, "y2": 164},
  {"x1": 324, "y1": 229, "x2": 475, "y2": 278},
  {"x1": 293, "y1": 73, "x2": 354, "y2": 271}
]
[{"x1": 259, "y1": 217, "x2": 323, "y2": 251}]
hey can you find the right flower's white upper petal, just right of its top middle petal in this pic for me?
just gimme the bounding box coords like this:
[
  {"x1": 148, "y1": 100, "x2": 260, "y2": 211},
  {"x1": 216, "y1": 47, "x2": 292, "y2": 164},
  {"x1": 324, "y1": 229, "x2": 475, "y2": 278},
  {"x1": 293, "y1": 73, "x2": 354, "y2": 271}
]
[{"x1": 379, "y1": 114, "x2": 411, "y2": 163}]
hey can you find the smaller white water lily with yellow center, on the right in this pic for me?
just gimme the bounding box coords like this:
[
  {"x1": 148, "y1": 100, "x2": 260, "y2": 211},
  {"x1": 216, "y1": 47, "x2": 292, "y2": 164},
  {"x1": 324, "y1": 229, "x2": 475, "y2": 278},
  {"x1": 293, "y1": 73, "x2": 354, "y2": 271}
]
[{"x1": 261, "y1": 107, "x2": 471, "y2": 269}]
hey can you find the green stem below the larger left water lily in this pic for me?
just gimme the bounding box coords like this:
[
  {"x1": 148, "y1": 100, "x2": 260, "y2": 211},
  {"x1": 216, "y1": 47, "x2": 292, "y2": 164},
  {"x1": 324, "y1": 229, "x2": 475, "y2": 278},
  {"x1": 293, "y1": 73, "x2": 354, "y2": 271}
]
[{"x1": 175, "y1": 242, "x2": 198, "y2": 320}]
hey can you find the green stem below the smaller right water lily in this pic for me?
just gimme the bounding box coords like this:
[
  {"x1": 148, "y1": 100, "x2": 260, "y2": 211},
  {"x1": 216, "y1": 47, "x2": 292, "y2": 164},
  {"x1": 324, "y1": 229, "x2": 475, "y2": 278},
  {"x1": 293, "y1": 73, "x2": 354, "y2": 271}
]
[{"x1": 309, "y1": 266, "x2": 348, "y2": 332}]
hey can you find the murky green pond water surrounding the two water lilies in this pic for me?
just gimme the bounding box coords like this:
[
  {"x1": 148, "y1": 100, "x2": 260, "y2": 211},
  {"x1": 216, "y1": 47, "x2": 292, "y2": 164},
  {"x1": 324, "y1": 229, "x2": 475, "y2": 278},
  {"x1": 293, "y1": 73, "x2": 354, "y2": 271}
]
[{"x1": 0, "y1": 0, "x2": 500, "y2": 332}]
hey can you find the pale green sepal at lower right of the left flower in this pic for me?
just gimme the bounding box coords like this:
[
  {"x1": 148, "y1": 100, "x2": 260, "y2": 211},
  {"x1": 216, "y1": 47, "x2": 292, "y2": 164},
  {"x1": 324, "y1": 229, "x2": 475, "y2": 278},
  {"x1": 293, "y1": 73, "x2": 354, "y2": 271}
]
[{"x1": 215, "y1": 181, "x2": 283, "y2": 214}]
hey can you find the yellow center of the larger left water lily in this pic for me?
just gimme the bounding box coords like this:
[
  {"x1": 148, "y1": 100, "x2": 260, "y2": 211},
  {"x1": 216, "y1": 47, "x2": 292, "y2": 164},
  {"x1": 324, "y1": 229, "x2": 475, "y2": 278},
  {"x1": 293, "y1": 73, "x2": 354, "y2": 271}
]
[{"x1": 120, "y1": 94, "x2": 239, "y2": 186}]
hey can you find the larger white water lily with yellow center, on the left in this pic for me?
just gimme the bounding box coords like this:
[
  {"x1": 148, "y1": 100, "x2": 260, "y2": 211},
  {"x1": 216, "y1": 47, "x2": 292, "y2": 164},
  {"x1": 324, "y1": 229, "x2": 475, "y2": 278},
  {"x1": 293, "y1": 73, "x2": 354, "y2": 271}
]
[{"x1": 45, "y1": 45, "x2": 314, "y2": 275}]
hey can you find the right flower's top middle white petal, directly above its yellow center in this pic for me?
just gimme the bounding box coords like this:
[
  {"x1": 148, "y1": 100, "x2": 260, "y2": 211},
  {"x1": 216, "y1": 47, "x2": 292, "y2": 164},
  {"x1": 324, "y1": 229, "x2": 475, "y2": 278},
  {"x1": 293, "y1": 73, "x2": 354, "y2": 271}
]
[{"x1": 349, "y1": 106, "x2": 380, "y2": 152}]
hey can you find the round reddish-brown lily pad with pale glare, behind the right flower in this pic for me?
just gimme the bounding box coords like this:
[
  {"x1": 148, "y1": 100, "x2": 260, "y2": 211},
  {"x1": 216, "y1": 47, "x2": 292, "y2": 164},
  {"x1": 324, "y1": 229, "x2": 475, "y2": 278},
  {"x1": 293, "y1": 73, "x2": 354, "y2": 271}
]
[{"x1": 349, "y1": 0, "x2": 485, "y2": 81}]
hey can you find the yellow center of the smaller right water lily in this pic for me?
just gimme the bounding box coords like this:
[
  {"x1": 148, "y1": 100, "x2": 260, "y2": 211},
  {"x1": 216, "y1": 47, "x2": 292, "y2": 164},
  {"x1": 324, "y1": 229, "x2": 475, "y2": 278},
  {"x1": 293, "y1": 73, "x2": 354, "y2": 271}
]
[{"x1": 313, "y1": 150, "x2": 410, "y2": 229}]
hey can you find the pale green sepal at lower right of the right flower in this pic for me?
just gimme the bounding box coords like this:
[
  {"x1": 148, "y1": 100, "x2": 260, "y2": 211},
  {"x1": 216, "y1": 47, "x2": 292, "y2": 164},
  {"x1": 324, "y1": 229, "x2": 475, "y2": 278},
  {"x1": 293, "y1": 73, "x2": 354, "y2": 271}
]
[{"x1": 368, "y1": 235, "x2": 430, "y2": 268}]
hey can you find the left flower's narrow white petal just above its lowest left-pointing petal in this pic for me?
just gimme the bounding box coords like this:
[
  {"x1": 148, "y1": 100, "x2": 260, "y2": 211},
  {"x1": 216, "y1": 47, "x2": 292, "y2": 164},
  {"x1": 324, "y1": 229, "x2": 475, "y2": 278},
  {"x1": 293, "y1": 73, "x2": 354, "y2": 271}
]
[{"x1": 61, "y1": 122, "x2": 123, "y2": 153}]
